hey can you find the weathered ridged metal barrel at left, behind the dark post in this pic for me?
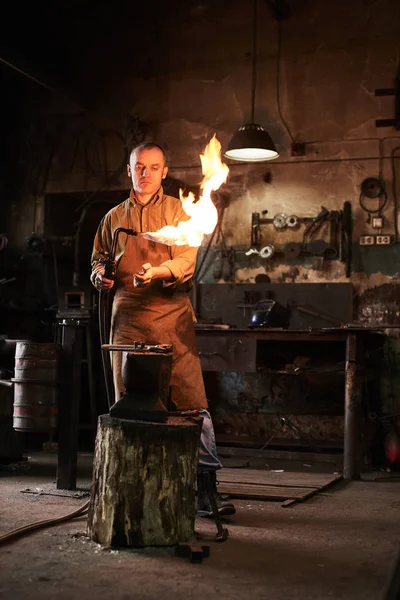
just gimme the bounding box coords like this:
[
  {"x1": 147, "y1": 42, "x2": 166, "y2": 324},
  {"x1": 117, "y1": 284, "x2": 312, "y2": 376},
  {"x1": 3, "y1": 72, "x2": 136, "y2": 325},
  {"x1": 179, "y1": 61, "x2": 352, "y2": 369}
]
[{"x1": 12, "y1": 341, "x2": 61, "y2": 433}]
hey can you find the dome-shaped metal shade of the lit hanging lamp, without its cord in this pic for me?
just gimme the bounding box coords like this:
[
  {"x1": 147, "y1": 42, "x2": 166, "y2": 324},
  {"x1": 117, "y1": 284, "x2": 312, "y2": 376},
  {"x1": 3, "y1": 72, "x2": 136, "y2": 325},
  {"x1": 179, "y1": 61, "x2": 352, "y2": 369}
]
[{"x1": 224, "y1": 123, "x2": 279, "y2": 162}]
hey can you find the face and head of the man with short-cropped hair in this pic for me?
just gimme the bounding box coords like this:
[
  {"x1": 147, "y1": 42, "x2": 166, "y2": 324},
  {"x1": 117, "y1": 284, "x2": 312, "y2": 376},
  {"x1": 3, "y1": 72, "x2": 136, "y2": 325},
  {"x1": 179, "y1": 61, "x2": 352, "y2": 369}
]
[{"x1": 128, "y1": 148, "x2": 168, "y2": 195}]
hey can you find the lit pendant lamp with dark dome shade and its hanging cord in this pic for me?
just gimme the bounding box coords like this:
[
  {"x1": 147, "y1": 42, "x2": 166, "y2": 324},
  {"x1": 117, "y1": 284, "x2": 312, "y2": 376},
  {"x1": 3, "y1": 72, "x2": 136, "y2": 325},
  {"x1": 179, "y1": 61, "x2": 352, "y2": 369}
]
[{"x1": 224, "y1": 0, "x2": 279, "y2": 162}]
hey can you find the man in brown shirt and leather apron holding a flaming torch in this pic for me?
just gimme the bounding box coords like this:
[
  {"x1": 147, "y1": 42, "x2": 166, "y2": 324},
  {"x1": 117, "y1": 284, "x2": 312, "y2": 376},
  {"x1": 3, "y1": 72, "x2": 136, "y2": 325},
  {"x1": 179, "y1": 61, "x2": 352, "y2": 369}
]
[{"x1": 91, "y1": 143, "x2": 235, "y2": 516}]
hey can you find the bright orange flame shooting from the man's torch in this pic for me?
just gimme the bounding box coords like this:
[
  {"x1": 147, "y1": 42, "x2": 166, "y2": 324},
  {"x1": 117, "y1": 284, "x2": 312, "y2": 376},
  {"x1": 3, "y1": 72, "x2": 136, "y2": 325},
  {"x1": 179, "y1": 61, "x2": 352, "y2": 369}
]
[{"x1": 142, "y1": 134, "x2": 229, "y2": 246}]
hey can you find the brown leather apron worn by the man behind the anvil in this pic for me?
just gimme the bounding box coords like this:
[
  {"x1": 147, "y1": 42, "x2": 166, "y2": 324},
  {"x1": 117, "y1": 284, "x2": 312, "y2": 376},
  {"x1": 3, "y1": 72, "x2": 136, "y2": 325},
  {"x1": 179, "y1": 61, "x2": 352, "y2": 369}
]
[{"x1": 111, "y1": 223, "x2": 208, "y2": 410}]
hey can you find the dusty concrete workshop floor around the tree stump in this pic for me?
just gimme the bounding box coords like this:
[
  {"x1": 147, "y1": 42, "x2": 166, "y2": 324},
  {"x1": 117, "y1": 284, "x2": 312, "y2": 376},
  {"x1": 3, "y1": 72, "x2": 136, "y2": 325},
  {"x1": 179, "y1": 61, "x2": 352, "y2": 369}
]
[{"x1": 0, "y1": 453, "x2": 400, "y2": 600}]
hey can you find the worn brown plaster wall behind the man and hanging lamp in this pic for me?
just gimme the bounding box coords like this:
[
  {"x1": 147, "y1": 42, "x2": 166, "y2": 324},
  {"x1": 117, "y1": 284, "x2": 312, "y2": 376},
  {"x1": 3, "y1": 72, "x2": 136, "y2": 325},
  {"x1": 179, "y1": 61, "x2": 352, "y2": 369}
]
[{"x1": 3, "y1": 0, "x2": 400, "y2": 450}]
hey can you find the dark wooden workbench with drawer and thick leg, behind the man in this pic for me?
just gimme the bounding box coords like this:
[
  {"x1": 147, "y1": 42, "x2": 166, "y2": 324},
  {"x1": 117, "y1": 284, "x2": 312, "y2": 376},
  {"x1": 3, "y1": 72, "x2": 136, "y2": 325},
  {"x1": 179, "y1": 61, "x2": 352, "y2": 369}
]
[{"x1": 196, "y1": 325, "x2": 384, "y2": 480}]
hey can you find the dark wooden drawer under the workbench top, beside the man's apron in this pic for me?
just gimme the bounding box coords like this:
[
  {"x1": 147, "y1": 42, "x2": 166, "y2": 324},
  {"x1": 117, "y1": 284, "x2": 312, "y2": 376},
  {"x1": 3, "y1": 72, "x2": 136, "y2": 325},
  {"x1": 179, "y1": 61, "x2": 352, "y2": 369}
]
[{"x1": 197, "y1": 335, "x2": 257, "y2": 373}]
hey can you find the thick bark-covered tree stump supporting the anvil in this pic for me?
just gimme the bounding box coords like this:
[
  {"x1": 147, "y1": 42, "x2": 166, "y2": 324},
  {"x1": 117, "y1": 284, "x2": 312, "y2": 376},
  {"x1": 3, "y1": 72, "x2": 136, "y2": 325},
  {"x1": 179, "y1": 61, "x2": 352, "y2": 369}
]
[{"x1": 88, "y1": 415, "x2": 203, "y2": 547}]
